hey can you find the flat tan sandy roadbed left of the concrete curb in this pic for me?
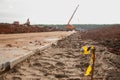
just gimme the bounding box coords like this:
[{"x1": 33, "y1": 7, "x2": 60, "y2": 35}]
[{"x1": 0, "y1": 31, "x2": 72, "y2": 68}]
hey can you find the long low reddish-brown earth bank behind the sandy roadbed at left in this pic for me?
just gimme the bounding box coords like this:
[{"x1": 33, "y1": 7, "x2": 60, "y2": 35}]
[{"x1": 0, "y1": 24, "x2": 62, "y2": 34}]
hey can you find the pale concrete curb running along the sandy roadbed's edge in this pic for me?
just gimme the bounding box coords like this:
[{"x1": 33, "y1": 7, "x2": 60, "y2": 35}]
[{"x1": 0, "y1": 32, "x2": 75, "y2": 73}]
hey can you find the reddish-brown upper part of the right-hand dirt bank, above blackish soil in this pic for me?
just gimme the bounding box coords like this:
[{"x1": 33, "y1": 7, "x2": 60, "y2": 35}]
[{"x1": 81, "y1": 25, "x2": 120, "y2": 41}]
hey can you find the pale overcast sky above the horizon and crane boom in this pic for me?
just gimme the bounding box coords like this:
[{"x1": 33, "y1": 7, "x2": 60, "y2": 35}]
[{"x1": 0, "y1": 0, "x2": 120, "y2": 24}]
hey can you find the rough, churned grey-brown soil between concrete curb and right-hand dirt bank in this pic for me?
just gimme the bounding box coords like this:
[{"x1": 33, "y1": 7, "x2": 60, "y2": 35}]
[{"x1": 1, "y1": 32, "x2": 120, "y2": 80}]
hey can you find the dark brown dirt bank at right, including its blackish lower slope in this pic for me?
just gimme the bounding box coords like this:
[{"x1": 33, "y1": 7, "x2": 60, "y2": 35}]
[{"x1": 79, "y1": 25, "x2": 120, "y2": 55}]
